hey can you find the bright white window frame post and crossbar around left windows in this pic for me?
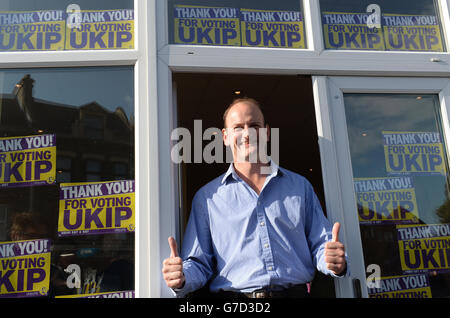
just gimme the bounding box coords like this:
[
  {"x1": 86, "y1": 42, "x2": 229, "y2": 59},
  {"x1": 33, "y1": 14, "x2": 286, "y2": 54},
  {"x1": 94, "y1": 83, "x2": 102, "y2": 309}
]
[{"x1": 0, "y1": 0, "x2": 160, "y2": 297}]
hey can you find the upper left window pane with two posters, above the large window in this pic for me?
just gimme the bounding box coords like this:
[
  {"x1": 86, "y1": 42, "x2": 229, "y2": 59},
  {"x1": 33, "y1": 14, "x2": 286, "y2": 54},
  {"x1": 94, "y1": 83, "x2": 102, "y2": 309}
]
[{"x1": 0, "y1": 0, "x2": 134, "y2": 52}]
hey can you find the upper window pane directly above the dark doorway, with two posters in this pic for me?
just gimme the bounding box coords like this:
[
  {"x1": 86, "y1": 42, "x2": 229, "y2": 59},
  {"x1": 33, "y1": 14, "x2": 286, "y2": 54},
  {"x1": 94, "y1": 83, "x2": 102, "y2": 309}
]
[{"x1": 168, "y1": 0, "x2": 306, "y2": 49}]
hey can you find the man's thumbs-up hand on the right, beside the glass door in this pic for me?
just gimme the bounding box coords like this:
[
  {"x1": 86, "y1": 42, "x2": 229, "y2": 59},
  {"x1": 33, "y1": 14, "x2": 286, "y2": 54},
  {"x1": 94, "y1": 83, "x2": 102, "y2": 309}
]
[{"x1": 325, "y1": 223, "x2": 347, "y2": 276}]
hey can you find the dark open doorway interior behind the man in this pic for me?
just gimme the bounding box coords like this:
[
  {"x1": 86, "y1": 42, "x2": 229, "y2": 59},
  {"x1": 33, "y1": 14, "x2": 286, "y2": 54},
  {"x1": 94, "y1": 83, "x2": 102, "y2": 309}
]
[{"x1": 173, "y1": 73, "x2": 335, "y2": 297}]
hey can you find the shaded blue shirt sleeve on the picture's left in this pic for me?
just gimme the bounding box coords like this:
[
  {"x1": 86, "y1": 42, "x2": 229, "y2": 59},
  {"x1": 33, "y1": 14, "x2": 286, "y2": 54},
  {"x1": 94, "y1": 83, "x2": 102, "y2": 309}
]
[{"x1": 174, "y1": 193, "x2": 214, "y2": 297}]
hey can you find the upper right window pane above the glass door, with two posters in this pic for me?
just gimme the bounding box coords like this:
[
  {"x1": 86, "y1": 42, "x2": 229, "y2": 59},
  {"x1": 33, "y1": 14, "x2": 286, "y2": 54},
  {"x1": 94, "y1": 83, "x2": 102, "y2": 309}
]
[{"x1": 320, "y1": 0, "x2": 445, "y2": 52}]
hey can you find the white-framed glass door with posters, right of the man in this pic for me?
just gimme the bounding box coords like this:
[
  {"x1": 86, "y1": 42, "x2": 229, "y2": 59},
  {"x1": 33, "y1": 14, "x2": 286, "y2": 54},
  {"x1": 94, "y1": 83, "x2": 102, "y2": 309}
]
[{"x1": 314, "y1": 77, "x2": 450, "y2": 298}]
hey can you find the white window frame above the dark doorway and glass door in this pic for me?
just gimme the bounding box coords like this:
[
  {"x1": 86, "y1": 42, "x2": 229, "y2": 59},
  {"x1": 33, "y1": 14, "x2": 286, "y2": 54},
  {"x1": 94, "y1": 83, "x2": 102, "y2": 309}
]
[{"x1": 156, "y1": 0, "x2": 450, "y2": 76}]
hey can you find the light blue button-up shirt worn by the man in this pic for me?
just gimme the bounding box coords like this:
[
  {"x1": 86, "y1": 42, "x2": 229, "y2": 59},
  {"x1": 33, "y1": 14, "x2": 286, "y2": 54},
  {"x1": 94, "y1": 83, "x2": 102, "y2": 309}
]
[{"x1": 176, "y1": 162, "x2": 344, "y2": 297}]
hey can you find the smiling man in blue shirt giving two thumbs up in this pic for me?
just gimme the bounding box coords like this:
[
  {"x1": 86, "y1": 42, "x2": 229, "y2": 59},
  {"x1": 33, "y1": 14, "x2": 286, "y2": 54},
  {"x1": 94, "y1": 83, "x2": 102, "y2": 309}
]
[{"x1": 162, "y1": 98, "x2": 347, "y2": 297}]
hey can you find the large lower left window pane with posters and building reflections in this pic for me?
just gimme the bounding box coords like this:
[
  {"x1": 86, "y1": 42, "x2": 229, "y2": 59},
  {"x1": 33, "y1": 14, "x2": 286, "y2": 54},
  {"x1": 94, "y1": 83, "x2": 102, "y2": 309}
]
[{"x1": 0, "y1": 67, "x2": 135, "y2": 298}]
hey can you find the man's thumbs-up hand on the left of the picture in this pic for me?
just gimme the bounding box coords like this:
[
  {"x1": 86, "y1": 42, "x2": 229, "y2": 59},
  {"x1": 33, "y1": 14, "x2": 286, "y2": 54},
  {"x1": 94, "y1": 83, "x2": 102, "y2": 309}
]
[{"x1": 162, "y1": 237, "x2": 185, "y2": 289}]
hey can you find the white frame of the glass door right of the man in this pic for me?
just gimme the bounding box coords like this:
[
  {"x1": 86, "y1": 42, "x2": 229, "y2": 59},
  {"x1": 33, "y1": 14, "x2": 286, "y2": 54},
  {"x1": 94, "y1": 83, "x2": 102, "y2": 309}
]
[{"x1": 313, "y1": 76, "x2": 450, "y2": 297}]
